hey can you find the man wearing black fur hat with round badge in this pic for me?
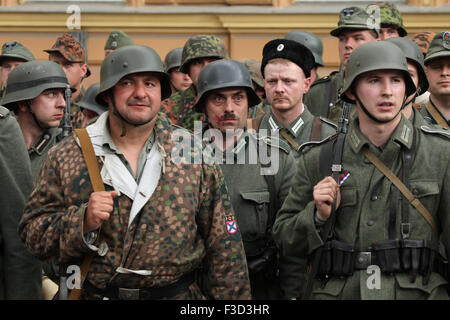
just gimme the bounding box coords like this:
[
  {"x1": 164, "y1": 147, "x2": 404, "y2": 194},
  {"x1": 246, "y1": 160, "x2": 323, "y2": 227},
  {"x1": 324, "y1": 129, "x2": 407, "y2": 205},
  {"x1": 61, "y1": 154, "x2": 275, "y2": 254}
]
[{"x1": 259, "y1": 39, "x2": 336, "y2": 165}]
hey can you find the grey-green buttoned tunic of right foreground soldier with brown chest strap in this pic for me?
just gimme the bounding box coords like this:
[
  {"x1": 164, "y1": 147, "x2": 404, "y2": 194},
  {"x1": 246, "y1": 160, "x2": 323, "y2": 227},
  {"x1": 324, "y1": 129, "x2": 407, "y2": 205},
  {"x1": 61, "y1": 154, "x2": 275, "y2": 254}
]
[{"x1": 274, "y1": 117, "x2": 450, "y2": 300}]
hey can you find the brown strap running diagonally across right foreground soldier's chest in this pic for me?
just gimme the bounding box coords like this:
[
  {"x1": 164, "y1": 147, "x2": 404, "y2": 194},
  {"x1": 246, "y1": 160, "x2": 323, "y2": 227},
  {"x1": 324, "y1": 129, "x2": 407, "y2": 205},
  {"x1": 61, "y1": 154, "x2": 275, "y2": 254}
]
[{"x1": 361, "y1": 146, "x2": 438, "y2": 233}]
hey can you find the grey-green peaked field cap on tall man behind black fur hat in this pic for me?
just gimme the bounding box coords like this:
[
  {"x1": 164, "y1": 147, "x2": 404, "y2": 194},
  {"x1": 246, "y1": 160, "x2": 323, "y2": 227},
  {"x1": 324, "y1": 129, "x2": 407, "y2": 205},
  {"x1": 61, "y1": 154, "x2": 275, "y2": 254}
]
[{"x1": 330, "y1": 7, "x2": 380, "y2": 38}]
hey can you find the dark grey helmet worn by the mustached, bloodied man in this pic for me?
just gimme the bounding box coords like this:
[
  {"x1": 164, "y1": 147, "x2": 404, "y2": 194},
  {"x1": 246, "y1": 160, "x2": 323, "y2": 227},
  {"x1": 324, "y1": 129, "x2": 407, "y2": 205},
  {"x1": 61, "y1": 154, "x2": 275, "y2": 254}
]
[{"x1": 194, "y1": 59, "x2": 261, "y2": 112}]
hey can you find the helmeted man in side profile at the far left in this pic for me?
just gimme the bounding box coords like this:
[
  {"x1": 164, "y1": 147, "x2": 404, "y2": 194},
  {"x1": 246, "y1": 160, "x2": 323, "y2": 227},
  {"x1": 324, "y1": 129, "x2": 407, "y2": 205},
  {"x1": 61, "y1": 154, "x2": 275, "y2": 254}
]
[{"x1": 2, "y1": 61, "x2": 69, "y2": 180}]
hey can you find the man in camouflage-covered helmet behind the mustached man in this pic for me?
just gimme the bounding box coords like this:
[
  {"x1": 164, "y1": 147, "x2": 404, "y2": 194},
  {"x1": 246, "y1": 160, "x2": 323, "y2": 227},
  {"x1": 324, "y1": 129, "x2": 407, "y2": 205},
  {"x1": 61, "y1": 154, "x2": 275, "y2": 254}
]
[{"x1": 161, "y1": 35, "x2": 228, "y2": 131}]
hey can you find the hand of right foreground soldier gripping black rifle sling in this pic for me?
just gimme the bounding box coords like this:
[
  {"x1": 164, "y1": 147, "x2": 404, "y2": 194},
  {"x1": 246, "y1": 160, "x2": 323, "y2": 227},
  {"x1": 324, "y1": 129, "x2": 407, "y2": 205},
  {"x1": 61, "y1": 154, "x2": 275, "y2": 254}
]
[{"x1": 313, "y1": 176, "x2": 341, "y2": 220}]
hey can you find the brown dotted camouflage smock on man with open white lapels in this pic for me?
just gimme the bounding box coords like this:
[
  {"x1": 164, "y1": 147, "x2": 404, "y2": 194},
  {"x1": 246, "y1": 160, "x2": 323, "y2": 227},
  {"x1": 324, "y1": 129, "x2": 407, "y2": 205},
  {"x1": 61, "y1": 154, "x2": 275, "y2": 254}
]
[{"x1": 19, "y1": 113, "x2": 250, "y2": 299}]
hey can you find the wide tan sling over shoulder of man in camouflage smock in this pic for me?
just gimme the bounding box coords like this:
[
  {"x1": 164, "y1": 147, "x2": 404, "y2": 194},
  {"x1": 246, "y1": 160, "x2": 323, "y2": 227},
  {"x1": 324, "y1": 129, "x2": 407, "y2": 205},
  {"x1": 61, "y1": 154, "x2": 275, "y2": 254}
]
[{"x1": 69, "y1": 128, "x2": 105, "y2": 300}]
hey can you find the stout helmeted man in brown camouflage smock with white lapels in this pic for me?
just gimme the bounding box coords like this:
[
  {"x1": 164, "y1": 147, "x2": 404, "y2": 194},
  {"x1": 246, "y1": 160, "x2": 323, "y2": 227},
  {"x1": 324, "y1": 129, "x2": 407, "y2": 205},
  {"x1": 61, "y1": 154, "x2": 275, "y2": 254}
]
[{"x1": 19, "y1": 46, "x2": 250, "y2": 299}]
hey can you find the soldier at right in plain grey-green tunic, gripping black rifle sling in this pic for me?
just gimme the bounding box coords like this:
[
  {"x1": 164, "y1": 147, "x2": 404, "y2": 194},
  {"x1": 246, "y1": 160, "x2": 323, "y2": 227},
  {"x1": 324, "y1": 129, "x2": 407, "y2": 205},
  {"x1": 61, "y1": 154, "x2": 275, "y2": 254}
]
[{"x1": 274, "y1": 41, "x2": 450, "y2": 300}]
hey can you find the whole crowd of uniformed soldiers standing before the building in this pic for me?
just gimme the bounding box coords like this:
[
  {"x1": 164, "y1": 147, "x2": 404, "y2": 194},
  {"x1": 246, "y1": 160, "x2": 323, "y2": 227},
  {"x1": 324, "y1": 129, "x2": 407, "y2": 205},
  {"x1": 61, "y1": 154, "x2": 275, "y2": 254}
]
[{"x1": 0, "y1": 3, "x2": 450, "y2": 300}]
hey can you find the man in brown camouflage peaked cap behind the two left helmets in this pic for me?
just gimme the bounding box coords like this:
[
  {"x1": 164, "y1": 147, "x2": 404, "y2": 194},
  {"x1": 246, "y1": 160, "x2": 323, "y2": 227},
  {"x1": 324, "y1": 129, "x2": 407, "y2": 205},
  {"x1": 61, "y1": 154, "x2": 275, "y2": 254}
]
[{"x1": 44, "y1": 33, "x2": 91, "y2": 128}]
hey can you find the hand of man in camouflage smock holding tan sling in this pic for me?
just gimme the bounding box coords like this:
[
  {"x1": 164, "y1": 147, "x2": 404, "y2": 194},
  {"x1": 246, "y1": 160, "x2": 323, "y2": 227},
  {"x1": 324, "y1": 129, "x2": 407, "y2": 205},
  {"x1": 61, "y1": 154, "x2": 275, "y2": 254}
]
[{"x1": 83, "y1": 190, "x2": 119, "y2": 233}]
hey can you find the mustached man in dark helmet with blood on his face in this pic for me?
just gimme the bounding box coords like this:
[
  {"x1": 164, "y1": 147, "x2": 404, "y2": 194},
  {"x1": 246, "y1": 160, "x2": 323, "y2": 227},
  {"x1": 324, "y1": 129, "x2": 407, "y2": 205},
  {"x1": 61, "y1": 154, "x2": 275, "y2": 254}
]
[{"x1": 194, "y1": 60, "x2": 295, "y2": 300}]
